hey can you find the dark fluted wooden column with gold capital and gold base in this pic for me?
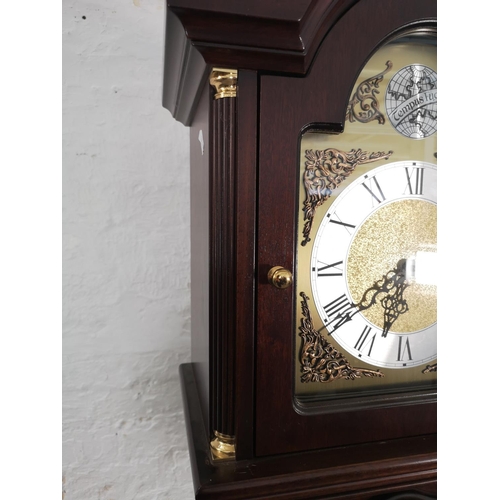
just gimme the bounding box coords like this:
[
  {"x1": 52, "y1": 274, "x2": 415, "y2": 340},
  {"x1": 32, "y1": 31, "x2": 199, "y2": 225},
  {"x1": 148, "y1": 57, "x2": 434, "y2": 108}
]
[{"x1": 210, "y1": 69, "x2": 237, "y2": 458}]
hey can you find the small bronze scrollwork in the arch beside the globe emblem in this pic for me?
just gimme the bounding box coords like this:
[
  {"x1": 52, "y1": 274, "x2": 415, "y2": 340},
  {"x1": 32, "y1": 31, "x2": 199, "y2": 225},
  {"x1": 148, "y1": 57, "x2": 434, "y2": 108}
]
[{"x1": 346, "y1": 61, "x2": 392, "y2": 125}]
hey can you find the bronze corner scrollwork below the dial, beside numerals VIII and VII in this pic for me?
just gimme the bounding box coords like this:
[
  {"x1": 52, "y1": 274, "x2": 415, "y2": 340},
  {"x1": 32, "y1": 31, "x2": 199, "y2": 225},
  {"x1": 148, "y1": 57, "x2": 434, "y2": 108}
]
[{"x1": 299, "y1": 292, "x2": 385, "y2": 383}]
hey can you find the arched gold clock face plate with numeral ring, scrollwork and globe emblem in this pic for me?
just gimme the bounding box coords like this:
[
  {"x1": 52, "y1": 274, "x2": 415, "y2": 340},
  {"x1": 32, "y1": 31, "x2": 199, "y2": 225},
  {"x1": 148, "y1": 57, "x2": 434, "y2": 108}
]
[{"x1": 294, "y1": 31, "x2": 437, "y2": 406}]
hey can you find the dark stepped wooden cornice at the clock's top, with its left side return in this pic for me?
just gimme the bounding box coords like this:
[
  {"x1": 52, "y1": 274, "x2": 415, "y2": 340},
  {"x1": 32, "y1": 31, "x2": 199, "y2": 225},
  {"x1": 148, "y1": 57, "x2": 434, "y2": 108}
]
[{"x1": 163, "y1": 0, "x2": 435, "y2": 125}]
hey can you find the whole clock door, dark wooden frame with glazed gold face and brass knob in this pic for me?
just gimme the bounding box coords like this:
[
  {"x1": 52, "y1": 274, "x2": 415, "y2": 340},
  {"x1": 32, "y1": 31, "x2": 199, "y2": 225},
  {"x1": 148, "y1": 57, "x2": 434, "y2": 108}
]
[{"x1": 256, "y1": 0, "x2": 437, "y2": 456}]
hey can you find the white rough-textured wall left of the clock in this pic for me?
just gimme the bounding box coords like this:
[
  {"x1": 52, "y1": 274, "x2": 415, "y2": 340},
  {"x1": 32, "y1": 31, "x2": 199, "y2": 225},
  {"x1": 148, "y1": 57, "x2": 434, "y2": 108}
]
[{"x1": 62, "y1": 0, "x2": 193, "y2": 500}]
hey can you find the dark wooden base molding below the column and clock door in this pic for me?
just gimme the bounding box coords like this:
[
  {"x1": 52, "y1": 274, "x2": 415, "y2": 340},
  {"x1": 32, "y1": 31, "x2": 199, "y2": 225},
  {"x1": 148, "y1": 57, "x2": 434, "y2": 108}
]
[{"x1": 180, "y1": 363, "x2": 437, "y2": 500}]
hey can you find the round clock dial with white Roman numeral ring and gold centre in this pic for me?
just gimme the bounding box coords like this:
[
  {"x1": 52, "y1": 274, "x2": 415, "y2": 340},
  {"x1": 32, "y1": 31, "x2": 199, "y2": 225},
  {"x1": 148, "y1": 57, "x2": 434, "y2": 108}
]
[{"x1": 311, "y1": 161, "x2": 437, "y2": 368}]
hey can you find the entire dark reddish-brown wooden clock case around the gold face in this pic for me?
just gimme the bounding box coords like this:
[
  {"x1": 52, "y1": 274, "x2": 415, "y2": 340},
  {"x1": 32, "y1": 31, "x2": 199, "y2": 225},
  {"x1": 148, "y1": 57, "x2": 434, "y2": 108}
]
[{"x1": 163, "y1": 0, "x2": 436, "y2": 500}]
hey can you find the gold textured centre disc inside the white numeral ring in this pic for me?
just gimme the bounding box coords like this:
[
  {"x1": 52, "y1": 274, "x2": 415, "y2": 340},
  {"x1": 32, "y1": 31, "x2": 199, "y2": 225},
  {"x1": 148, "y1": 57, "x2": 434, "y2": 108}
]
[{"x1": 347, "y1": 199, "x2": 437, "y2": 333}]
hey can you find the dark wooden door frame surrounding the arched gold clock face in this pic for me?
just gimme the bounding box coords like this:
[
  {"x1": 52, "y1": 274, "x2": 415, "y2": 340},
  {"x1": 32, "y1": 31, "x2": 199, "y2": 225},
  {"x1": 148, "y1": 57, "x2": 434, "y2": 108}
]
[{"x1": 256, "y1": 0, "x2": 436, "y2": 456}]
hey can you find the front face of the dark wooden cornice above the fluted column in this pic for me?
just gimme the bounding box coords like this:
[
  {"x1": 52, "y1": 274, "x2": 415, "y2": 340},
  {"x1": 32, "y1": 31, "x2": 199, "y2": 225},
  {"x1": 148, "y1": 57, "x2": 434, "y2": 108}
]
[{"x1": 168, "y1": 0, "x2": 359, "y2": 64}]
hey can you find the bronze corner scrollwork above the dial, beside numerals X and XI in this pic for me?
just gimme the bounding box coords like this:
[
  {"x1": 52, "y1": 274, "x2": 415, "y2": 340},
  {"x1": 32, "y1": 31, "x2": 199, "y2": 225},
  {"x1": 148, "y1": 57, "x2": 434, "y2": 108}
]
[{"x1": 301, "y1": 148, "x2": 392, "y2": 246}]
